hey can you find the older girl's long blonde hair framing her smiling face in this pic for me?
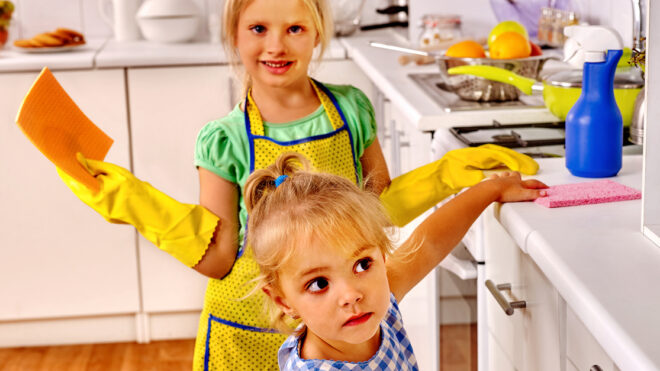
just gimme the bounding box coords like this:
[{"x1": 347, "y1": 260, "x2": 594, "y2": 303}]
[{"x1": 222, "y1": 0, "x2": 334, "y2": 91}]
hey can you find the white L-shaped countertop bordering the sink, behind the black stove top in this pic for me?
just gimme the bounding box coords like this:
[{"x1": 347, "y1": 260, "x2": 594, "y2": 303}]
[{"x1": 341, "y1": 31, "x2": 558, "y2": 131}]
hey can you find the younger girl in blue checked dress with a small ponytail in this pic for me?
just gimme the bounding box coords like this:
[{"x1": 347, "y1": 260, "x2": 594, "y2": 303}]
[{"x1": 245, "y1": 154, "x2": 546, "y2": 370}]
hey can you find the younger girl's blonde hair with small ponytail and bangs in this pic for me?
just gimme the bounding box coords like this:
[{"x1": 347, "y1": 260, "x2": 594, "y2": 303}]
[{"x1": 244, "y1": 153, "x2": 392, "y2": 333}]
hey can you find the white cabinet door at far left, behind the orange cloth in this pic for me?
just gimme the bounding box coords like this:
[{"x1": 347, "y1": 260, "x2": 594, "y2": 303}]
[{"x1": 0, "y1": 70, "x2": 139, "y2": 322}]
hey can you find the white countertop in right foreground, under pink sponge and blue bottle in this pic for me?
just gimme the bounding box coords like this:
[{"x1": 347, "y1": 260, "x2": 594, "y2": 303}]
[{"x1": 498, "y1": 156, "x2": 660, "y2": 370}]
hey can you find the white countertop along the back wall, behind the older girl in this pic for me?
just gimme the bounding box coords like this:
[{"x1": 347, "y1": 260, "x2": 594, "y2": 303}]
[{"x1": 0, "y1": 39, "x2": 346, "y2": 72}]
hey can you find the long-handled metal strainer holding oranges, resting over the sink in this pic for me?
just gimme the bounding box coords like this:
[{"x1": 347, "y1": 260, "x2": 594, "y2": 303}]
[{"x1": 369, "y1": 42, "x2": 556, "y2": 102}]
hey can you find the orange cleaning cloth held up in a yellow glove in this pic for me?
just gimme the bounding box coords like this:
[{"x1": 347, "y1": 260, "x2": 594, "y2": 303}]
[{"x1": 16, "y1": 67, "x2": 113, "y2": 192}]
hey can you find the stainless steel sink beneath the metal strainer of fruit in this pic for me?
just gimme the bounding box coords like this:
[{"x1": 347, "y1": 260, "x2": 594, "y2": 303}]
[{"x1": 408, "y1": 73, "x2": 545, "y2": 112}]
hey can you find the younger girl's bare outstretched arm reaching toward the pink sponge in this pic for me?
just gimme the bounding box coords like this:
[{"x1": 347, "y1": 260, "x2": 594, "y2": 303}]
[{"x1": 387, "y1": 172, "x2": 547, "y2": 300}]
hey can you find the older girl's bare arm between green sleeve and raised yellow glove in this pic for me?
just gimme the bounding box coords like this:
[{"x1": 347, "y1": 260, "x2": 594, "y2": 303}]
[{"x1": 193, "y1": 167, "x2": 239, "y2": 278}]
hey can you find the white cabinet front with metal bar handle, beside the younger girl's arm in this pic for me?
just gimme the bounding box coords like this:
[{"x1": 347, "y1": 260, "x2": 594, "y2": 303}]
[{"x1": 483, "y1": 205, "x2": 565, "y2": 370}]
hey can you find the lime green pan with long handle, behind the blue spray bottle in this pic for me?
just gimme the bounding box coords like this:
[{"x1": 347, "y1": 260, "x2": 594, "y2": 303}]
[{"x1": 447, "y1": 66, "x2": 644, "y2": 126}]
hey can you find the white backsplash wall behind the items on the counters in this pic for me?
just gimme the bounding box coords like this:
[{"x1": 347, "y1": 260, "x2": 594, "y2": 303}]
[{"x1": 9, "y1": 0, "x2": 648, "y2": 46}]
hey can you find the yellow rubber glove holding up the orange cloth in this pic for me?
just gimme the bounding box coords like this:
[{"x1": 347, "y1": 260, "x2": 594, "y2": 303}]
[{"x1": 57, "y1": 153, "x2": 220, "y2": 267}]
